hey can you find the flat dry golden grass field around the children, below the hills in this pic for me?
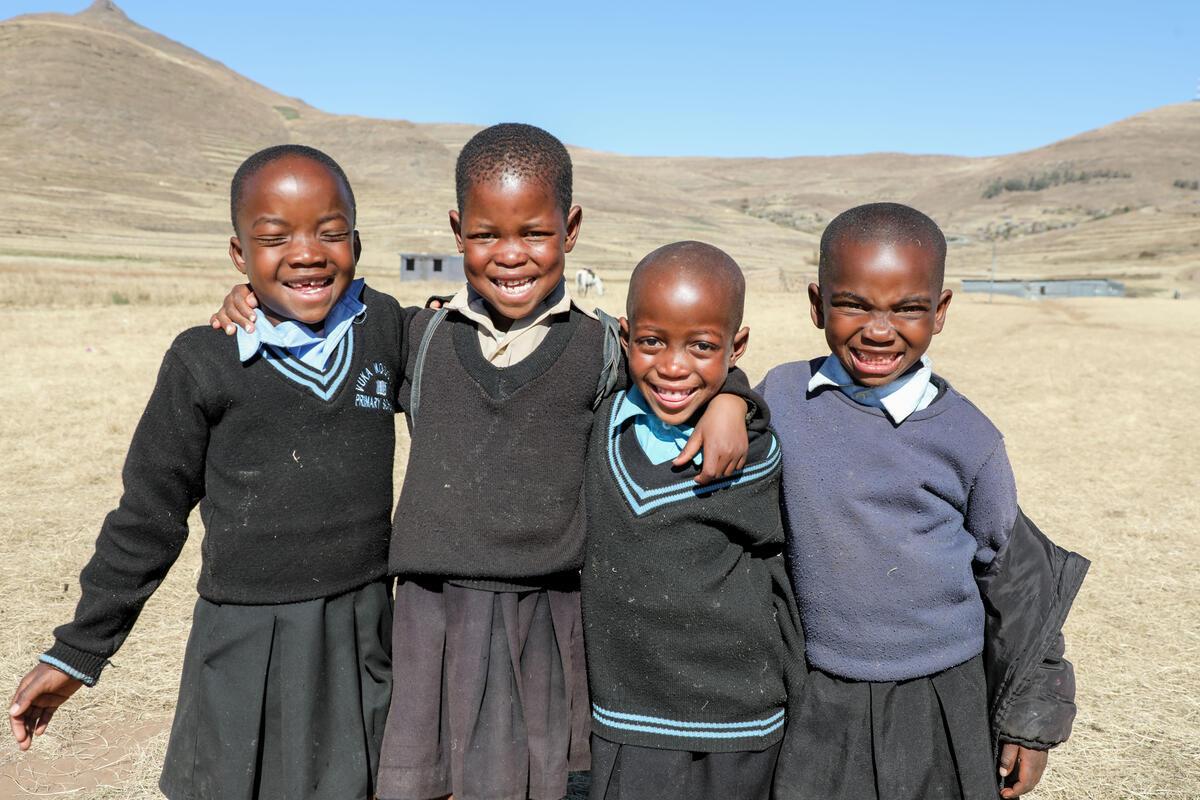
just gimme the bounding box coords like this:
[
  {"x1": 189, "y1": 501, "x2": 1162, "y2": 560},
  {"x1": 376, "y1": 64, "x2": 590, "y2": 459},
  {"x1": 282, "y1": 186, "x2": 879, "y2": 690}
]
[{"x1": 0, "y1": 260, "x2": 1200, "y2": 800}]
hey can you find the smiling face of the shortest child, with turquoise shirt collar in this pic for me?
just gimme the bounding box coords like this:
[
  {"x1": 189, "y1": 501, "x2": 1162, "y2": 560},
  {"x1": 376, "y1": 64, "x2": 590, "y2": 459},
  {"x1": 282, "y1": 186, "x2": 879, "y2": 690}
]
[{"x1": 620, "y1": 271, "x2": 750, "y2": 425}]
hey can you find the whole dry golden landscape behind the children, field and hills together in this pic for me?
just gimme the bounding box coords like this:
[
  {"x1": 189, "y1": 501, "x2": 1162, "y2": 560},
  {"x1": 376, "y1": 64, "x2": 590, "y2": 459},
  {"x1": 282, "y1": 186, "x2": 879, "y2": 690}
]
[{"x1": 0, "y1": 0, "x2": 1200, "y2": 800}]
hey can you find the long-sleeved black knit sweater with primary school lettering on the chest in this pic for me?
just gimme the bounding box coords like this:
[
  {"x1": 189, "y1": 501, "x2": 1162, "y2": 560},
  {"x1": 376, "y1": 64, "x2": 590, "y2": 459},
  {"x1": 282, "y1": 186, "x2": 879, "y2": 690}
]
[{"x1": 46, "y1": 288, "x2": 407, "y2": 682}]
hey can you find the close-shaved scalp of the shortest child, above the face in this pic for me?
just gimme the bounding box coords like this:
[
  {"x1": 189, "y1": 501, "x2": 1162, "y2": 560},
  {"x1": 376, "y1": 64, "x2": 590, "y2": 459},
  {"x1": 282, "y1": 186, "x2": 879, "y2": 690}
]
[{"x1": 625, "y1": 241, "x2": 746, "y2": 335}]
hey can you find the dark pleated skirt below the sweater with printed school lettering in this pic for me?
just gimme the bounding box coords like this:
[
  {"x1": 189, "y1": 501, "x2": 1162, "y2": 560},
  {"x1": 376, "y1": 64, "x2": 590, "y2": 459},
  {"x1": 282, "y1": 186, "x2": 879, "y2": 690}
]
[{"x1": 158, "y1": 582, "x2": 391, "y2": 800}]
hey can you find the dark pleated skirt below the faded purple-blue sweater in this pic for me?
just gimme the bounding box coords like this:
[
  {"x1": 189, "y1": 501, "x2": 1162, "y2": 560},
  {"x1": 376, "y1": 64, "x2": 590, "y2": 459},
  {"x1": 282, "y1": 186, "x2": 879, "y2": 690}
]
[{"x1": 781, "y1": 656, "x2": 1000, "y2": 800}]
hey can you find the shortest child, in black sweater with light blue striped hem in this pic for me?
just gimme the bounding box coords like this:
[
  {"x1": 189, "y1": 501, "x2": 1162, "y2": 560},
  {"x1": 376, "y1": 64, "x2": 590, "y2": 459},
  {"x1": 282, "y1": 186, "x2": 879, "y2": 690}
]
[{"x1": 583, "y1": 242, "x2": 804, "y2": 800}]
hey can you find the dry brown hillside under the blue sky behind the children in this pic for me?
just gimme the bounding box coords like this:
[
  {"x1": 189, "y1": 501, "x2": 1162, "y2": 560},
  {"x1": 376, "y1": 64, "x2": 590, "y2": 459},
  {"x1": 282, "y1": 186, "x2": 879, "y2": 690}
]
[{"x1": 0, "y1": 0, "x2": 1200, "y2": 290}]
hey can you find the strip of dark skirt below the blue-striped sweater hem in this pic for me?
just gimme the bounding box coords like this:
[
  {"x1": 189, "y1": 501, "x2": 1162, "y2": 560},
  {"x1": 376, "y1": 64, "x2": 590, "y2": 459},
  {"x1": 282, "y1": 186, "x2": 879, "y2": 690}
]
[{"x1": 589, "y1": 735, "x2": 782, "y2": 800}]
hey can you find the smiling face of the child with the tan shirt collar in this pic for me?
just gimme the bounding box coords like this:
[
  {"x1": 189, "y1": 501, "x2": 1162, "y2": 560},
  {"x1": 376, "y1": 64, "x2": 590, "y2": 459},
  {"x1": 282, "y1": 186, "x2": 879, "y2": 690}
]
[{"x1": 450, "y1": 174, "x2": 583, "y2": 326}]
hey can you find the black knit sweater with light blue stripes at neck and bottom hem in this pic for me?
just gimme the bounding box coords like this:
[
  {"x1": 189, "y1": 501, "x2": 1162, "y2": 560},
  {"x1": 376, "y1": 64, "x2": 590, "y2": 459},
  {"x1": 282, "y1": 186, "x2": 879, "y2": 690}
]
[{"x1": 582, "y1": 395, "x2": 804, "y2": 752}]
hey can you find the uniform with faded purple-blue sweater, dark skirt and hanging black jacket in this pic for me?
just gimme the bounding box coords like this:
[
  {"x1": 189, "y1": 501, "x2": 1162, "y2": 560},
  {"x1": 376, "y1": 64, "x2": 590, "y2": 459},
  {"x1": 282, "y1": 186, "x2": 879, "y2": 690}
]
[{"x1": 760, "y1": 356, "x2": 1086, "y2": 800}]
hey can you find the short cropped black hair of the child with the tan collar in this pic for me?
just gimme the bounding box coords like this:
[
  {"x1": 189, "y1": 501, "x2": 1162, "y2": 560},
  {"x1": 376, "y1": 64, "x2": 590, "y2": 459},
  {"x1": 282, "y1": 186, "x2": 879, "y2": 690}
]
[{"x1": 454, "y1": 122, "x2": 572, "y2": 217}]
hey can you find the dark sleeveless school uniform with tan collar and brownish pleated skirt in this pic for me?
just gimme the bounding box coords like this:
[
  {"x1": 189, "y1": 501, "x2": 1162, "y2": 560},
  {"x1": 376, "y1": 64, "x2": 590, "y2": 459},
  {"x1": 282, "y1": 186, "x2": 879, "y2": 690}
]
[{"x1": 378, "y1": 285, "x2": 605, "y2": 800}]
